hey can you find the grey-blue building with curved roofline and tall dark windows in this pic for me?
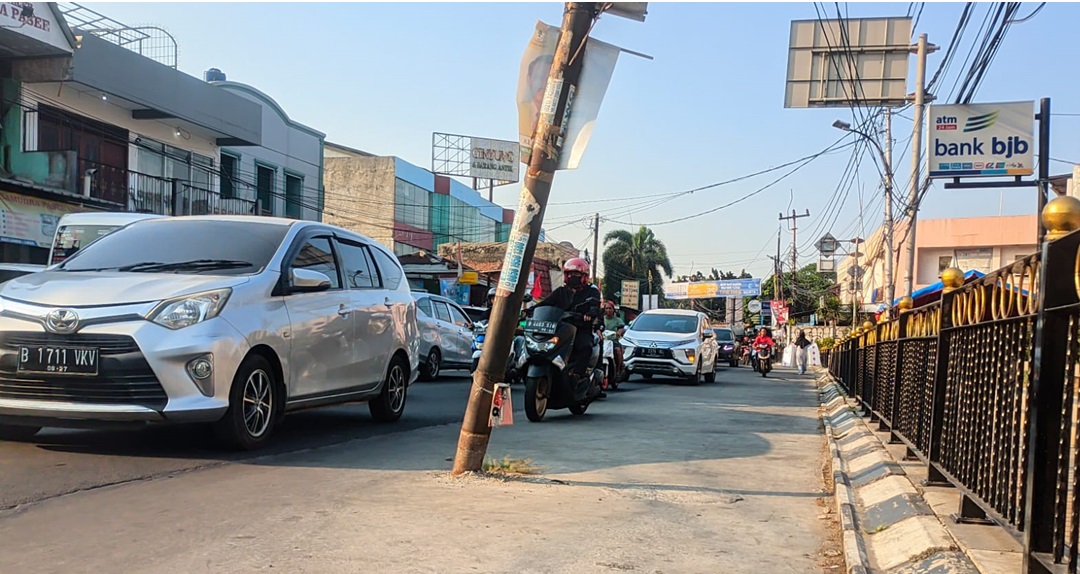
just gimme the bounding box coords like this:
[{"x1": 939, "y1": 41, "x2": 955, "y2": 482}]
[{"x1": 204, "y1": 68, "x2": 326, "y2": 222}]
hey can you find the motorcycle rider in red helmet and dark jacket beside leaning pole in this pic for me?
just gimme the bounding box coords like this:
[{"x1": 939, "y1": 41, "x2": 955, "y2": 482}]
[{"x1": 534, "y1": 257, "x2": 604, "y2": 398}]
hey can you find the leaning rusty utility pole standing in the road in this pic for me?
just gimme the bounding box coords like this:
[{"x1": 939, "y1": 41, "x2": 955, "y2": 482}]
[{"x1": 451, "y1": 2, "x2": 598, "y2": 476}]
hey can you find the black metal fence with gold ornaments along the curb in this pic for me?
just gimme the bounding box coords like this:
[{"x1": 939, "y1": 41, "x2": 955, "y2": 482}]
[{"x1": 828, "y1": 243, "x2": 1080, "y2": 574}]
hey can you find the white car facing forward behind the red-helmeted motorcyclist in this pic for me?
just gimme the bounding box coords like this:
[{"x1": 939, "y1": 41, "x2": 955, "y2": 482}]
[{"x1": 622, "y1": 309, "x2": 719, "y2": 385}]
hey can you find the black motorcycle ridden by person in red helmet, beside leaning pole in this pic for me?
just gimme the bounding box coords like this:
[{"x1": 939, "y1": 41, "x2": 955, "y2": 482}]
[{"x1": 525, "y1": 299, "x2": 604, "y2": 423}]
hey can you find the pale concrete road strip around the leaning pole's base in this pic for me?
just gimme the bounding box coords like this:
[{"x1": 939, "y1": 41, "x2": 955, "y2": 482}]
[{"x1": 0, "y1": 369, "x2": 840, "y2": 574}]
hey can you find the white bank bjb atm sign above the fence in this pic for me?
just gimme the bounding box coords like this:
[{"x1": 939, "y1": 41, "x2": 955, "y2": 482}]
[{"x1": 927, "y1": 102, "x2": 1035, "y2": 177}]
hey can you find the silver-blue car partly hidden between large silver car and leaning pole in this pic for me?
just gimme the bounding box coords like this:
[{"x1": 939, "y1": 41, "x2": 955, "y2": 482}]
[{"x1": 413, "y1": 293, "x2": 473, "y2": 381}]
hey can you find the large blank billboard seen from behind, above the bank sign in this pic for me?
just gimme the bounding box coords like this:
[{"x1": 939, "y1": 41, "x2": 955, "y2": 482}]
[{"x1": 784, "y1": 17, "x2": 912, "y2": 108}]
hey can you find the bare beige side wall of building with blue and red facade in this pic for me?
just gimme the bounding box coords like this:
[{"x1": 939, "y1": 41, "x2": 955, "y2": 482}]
[{"x1": 323, "y1": 157, "x2": 395, "y2": 249}]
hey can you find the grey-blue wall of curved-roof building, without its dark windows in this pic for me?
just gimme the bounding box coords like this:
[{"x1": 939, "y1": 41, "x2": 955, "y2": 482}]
[{"x1": 211, "y1": 81, "x2": 326, "y2": 221}]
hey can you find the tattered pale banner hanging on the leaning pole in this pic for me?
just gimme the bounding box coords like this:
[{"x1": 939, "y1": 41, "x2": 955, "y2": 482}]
[{"x1": 517, "y1": 22, "x2": 621, "y2": 170}]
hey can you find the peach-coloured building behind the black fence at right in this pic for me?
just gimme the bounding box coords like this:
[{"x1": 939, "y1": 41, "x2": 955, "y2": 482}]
[{"x1": 837, "y1": 214, "x2": 1038, "y2": 311}]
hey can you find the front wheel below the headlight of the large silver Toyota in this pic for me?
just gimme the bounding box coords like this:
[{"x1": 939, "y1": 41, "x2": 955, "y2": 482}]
[{"x1": 214, "y1": 355, "x2": 281, "y2": 451}]
